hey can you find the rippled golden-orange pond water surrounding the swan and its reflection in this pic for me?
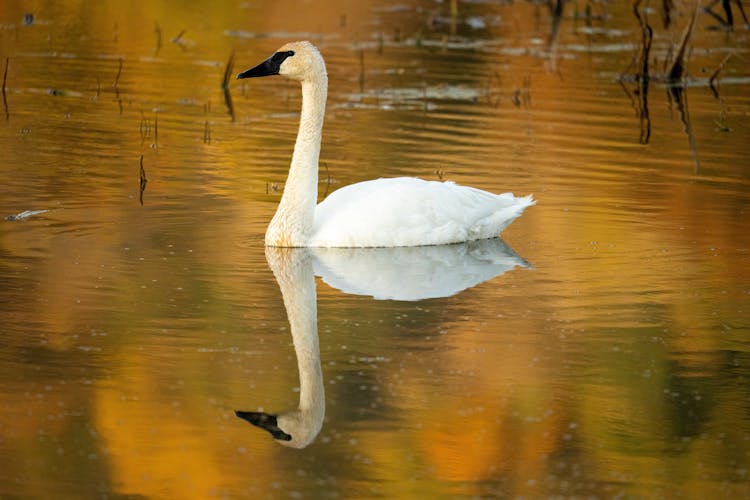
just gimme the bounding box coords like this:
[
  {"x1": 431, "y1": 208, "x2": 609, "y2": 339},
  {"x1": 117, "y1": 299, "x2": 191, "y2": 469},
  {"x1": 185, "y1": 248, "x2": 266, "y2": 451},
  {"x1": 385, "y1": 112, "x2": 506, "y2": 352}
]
[{"x1": 0, "y1": 0, "x2": 750, "y2": 498}]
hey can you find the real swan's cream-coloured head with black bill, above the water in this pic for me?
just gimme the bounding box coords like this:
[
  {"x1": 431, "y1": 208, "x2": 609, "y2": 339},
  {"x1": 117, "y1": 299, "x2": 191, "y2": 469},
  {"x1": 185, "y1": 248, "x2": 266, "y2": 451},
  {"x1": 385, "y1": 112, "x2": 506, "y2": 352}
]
[{"x1": 237, "y1": 42, "x2": 326, "y2": 81}]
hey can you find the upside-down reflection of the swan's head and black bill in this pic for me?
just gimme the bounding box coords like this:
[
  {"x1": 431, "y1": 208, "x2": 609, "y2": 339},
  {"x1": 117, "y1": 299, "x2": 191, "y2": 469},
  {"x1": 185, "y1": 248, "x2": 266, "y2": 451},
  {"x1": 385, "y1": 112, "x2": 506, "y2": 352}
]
[{"x1": 234, "y1": 410, "x2": 323, "y2": 448}]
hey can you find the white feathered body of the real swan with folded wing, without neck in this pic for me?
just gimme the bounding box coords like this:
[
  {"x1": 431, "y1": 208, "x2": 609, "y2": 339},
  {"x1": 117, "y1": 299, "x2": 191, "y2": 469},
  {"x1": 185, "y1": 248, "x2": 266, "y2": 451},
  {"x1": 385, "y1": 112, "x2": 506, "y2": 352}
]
[{"x1": 312, "y1": 177, "x2": 533, "y2": 247}]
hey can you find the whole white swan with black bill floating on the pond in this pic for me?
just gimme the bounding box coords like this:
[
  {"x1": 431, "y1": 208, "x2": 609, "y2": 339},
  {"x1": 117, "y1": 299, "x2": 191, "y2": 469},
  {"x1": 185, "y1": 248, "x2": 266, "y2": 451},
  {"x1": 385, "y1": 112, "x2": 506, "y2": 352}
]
[{"x1": 237, "y1": 41, "x2": 536, "y2": 247}]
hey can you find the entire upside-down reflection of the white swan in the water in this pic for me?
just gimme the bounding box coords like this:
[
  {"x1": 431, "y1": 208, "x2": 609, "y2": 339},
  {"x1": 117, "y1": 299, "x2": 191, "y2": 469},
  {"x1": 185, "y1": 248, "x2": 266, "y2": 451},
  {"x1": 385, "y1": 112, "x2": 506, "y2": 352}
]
[{"x1": 235, "y1": 238, "x2": 529, "y2": 448}]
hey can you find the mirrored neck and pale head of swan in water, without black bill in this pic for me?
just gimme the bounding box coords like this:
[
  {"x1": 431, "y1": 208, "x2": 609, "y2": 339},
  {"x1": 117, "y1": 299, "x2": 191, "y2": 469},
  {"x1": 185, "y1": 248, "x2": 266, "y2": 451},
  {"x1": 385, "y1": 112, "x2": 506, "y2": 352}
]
[{"x1": 266, "y1": 247, "x2": 325, "y2": 447}]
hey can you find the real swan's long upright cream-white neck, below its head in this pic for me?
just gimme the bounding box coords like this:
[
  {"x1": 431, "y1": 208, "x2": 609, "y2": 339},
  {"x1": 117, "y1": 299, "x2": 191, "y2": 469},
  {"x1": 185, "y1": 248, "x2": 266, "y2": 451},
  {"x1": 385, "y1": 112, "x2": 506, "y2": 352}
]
[{"x1": 266, "y1": 77, "x2": 328, "y2": 247}]
